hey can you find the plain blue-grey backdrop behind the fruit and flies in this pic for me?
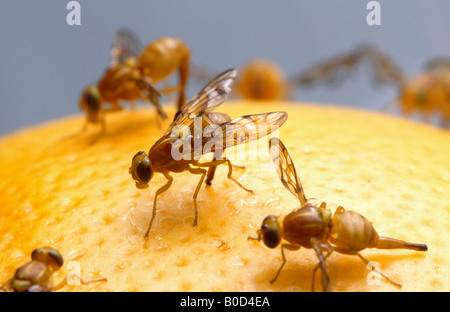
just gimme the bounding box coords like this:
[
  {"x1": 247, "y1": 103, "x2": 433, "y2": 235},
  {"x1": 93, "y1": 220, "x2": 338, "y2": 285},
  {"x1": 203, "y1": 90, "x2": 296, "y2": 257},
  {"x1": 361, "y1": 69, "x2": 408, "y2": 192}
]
[{"x1": 0, "y1": 0, "x2": 450, "y2": 134}]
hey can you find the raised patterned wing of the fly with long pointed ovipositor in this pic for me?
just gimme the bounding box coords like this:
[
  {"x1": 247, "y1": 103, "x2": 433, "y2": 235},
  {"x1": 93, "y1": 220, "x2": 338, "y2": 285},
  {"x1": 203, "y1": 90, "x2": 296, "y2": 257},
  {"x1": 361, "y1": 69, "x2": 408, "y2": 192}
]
[{"x1": 269, "y1": 138, "x2": 307, "y2": 207}]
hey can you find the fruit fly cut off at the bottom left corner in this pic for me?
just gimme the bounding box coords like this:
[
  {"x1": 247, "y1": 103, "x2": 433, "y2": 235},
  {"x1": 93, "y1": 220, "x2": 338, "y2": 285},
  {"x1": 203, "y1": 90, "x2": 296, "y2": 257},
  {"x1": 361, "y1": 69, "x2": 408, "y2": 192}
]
[{"x1": 0, "y1": 247, "x2": 106, "y2": 292}]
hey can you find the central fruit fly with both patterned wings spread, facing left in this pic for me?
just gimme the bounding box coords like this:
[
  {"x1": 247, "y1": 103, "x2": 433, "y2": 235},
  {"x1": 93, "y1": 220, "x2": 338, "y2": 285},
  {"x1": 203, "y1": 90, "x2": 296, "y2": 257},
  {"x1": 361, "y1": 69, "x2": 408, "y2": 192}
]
[{"x1": 129, "y1": 69, "x2": 287, "y2": 237}]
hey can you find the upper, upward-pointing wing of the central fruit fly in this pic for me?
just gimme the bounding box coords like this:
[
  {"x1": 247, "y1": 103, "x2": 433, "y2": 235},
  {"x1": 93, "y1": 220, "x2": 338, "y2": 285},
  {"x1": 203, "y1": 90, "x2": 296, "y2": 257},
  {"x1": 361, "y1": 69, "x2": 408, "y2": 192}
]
[{"x1": 166, "y1": 69, "x2": 236, "y2": 134}]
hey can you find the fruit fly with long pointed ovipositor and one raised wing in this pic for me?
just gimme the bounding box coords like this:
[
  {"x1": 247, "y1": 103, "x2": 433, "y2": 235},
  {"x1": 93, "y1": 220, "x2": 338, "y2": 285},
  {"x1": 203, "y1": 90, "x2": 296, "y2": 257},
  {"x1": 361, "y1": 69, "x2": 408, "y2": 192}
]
[{"x1": 249, "y1": 138, "x2": 428, "y2": 291}]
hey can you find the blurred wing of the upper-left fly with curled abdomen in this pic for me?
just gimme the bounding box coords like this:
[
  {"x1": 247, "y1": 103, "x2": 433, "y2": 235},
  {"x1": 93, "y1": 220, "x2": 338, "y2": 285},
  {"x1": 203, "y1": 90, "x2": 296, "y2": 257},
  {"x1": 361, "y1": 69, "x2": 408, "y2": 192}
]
[{"x1": 109, "y1": 28, "x2": 142, "y2": 67}]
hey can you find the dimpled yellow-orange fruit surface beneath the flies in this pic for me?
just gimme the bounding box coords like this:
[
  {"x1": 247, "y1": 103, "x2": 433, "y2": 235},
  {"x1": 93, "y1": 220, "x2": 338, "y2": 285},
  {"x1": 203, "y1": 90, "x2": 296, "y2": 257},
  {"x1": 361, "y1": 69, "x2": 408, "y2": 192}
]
[{"x1": 0, "y1": 100, "x2": 450, "y2": 291}]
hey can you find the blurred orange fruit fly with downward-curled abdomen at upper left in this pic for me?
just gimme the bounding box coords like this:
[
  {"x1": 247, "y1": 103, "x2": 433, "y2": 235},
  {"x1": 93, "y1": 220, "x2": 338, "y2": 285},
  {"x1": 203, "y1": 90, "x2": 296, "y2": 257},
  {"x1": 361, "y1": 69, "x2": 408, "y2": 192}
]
[{"x1": 79, "y1": 29, "x2": 190, "y2": 141}]
